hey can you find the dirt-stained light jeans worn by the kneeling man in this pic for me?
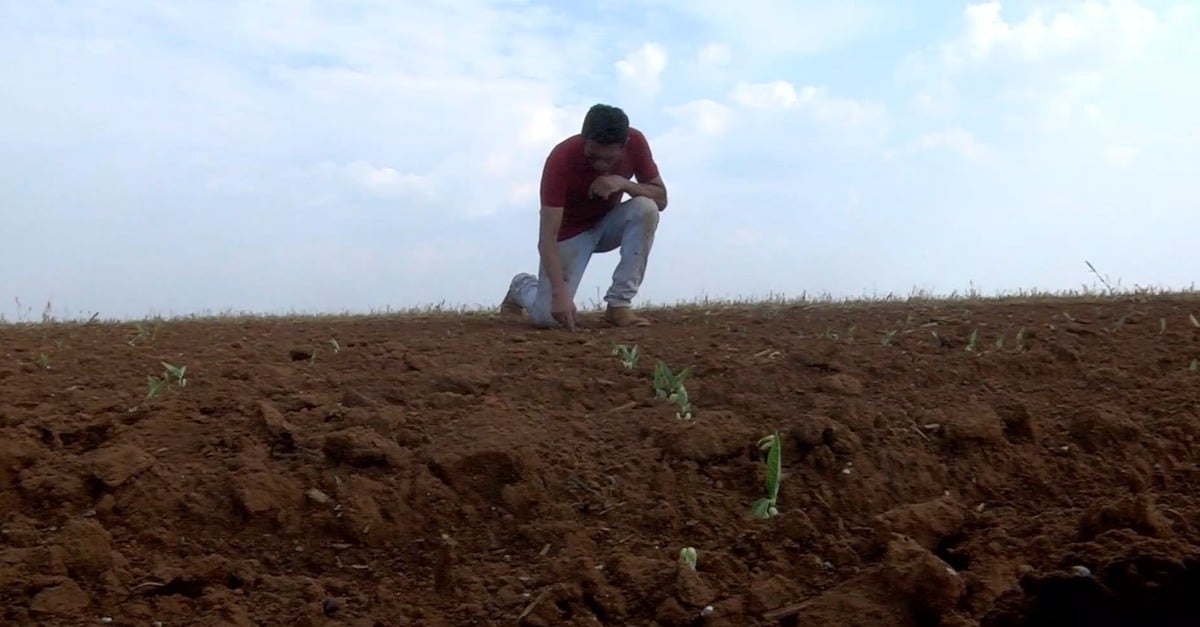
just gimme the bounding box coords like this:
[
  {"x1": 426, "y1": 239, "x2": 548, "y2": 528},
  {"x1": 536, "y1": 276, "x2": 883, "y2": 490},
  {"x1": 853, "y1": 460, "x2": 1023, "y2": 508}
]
[{"x1": 511, "y1": 196, "x2": 659, "y2": 327}]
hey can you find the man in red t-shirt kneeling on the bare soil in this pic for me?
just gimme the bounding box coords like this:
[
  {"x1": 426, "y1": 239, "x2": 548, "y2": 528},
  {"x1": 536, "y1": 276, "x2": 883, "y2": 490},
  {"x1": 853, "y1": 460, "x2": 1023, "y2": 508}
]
[{"x1": 500, "y1": 105, "x2": 667, "y2": 330}]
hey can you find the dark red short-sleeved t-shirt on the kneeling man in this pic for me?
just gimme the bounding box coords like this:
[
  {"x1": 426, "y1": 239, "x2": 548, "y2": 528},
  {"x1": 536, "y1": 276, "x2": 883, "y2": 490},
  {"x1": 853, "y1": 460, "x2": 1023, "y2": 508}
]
[{"x1": 541, "y1": 129, "x2": 659, "y2": 241}]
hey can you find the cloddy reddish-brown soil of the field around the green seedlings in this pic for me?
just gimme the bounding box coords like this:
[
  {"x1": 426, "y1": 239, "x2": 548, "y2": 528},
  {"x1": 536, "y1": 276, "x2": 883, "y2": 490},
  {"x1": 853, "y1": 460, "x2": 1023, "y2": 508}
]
[{"x1": 0, "y1": 297, "x2": 1200, "y2": 627}]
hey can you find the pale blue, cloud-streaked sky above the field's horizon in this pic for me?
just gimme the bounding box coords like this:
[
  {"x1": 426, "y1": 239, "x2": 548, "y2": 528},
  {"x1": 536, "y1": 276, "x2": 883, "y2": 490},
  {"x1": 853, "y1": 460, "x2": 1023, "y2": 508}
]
[{"x1": 0, "y1": 0, "x2": 1200, "y2": 320}]
